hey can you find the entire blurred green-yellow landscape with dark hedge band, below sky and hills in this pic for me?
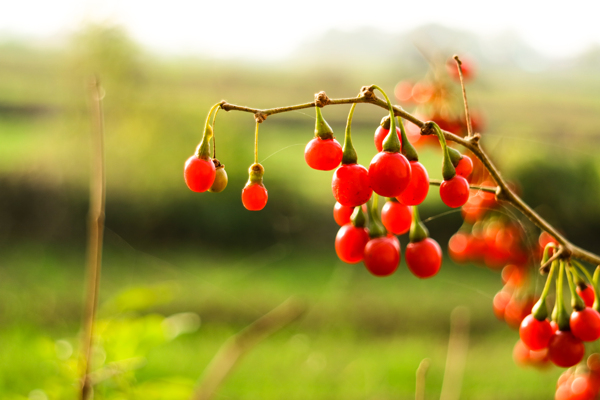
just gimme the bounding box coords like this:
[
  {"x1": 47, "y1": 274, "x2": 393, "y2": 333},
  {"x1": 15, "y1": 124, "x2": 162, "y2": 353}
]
[{"x1": 0, "y1": 27, "x2": 600, "y2": 400}]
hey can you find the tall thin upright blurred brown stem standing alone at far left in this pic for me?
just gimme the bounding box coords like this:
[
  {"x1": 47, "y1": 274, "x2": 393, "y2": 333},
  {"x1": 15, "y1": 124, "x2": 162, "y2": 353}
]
[{"x1": 80, "y1": 78, "x2": 106, "y2": 400}]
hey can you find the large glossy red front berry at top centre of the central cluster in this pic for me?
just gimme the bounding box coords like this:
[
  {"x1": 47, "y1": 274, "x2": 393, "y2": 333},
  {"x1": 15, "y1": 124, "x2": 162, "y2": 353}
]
[{"x1": 369, "y1": 151, "x2": 411, "y2": 197}]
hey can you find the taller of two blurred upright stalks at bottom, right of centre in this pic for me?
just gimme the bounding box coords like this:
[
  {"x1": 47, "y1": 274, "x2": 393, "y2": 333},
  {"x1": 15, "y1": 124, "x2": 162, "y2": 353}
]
[{"x1": 440, "y1": 307, "x2": 469, "y2": 400}]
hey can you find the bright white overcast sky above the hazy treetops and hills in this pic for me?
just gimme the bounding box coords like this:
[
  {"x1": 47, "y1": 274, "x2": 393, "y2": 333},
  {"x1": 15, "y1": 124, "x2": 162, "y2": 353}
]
[{"x1": 0, "y1": 0, "x2": 600, "y2": 60}]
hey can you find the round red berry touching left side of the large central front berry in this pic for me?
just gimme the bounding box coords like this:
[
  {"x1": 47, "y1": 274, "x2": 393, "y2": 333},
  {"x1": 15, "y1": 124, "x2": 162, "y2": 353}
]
[{"x1": 331, "y1": 164, "x2": 373, "y2": 207}]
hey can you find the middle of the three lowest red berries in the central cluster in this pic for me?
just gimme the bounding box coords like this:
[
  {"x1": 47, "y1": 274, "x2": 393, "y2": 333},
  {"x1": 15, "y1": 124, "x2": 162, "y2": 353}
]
[{"x1": 363, "y1": 236, "x2": 400, "y2": 276}]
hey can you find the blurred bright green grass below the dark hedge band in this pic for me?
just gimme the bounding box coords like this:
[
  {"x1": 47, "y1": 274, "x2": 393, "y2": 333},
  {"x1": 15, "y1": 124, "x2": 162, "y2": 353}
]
[{"x1": 0, "y1": 244, "x2": 560, "y2": 399}]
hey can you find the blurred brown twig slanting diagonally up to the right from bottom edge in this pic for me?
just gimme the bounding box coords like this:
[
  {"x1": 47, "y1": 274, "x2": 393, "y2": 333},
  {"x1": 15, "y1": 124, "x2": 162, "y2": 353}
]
[{"x1": 191, "y1": 298, "x2": 306, "y2": 400}]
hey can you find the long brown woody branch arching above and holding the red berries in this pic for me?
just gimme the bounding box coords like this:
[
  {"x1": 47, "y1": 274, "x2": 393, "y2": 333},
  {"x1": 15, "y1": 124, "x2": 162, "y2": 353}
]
[{"x1": 221, "y1": 86, "x2": 600, "y2": 265}]
